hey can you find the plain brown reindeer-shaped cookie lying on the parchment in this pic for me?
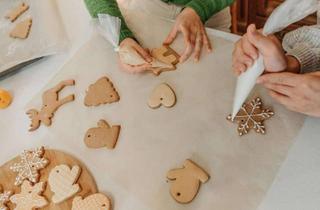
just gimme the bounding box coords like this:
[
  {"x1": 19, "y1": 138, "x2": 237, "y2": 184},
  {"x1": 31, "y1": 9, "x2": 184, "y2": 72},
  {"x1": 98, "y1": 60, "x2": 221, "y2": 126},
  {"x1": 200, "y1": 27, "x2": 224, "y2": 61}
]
[{"x1": 27, "y1": 80, "x2": 75, "y2": 131}]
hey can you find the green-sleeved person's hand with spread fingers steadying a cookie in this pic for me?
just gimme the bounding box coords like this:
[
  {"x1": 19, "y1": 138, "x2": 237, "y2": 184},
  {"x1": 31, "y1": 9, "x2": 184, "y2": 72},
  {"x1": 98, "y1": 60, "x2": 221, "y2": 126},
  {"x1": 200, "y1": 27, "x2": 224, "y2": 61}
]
[{"x1": 163, "y1": 8, "x2": 212, "y2": 63}]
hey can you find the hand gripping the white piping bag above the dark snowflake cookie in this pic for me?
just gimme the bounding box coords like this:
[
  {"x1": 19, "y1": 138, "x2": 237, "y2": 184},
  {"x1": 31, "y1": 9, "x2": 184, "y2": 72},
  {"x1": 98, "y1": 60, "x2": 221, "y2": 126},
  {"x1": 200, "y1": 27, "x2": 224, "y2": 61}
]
[{"x1": 232, "y1": 24, "x2": 288, "y2": 75}]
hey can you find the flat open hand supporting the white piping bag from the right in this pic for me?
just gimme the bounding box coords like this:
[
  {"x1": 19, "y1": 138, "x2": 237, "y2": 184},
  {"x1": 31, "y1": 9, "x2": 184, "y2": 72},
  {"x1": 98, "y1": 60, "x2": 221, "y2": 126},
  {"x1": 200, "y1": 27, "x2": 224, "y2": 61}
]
[{"x1": 257, "y1": 72, "x2": 320, "y2": 117}]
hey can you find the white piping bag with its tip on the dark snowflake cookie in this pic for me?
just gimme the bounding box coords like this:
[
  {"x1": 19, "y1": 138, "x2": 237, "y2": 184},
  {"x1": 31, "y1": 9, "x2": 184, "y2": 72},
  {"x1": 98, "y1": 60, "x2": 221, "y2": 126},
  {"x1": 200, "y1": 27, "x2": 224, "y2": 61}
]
[{"x1": 232, "y1": 0, "x2": 319, "y2": 120}]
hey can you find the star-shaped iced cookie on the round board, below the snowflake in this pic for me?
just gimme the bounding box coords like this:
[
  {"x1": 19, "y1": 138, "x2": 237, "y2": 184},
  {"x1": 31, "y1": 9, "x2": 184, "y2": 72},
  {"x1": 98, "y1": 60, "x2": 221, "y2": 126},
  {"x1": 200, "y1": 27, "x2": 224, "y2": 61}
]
[{"x1": 10, "y1": 181, "x2": 48, "y2": 210}]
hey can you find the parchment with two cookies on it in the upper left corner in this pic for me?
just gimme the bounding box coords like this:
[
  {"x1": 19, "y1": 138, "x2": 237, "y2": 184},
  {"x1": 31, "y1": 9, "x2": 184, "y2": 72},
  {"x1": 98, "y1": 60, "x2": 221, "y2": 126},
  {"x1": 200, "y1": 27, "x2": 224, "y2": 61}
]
[{"x1": 0, "y1": 0, "x2": 68, "y2": 72}]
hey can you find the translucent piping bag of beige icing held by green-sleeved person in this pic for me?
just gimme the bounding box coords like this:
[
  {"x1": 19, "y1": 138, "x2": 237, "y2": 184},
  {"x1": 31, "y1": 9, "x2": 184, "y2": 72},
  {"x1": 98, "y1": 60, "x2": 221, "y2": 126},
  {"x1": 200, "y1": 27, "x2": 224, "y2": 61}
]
[{"x1": 96, "y1": 14, "x2": 172, "y2": 68}]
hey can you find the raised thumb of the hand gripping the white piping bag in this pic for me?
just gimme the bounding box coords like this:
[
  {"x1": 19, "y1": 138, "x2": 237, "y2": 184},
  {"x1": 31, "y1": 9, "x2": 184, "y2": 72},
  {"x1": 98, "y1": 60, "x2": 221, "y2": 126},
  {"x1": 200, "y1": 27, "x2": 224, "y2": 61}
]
[{"x1": 247, "y1": 24, "x2": 272, "y2": 53}]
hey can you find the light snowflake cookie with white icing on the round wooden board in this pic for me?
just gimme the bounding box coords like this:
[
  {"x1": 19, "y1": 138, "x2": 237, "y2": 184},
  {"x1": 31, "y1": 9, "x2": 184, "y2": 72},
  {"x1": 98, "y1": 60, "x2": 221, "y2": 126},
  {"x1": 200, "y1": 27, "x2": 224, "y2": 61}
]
[{"x1": 10, "y1": 147, "x2": 49, "y2": 186}]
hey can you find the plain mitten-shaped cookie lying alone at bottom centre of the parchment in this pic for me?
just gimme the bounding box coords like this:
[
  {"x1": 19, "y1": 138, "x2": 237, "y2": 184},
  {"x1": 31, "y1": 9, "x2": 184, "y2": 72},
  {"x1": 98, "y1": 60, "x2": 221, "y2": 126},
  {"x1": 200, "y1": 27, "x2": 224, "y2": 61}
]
[{"x1": 167, "y1": 160, "x2": 210, "y2": 204}]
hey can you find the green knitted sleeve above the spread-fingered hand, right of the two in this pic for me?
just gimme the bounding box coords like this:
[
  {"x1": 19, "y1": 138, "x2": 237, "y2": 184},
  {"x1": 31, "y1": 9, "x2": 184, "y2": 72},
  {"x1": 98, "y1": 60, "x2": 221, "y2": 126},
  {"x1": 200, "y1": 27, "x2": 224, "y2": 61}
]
[{"x1": 186, "y1": 0, "x2": 234, "y2": 23}]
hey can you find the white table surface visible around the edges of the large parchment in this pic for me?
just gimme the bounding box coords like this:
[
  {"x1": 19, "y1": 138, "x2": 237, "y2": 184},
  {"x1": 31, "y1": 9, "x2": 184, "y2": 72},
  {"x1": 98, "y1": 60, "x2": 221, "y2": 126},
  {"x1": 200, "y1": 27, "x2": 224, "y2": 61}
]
[{"x1": 0, "y1": 0, "x2": 320, "y2": 210}]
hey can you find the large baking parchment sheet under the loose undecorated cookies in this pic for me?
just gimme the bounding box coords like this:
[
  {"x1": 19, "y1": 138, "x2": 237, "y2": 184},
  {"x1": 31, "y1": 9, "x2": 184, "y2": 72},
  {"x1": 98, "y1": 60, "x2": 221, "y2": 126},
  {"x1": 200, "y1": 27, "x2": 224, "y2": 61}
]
[{"x1": 26, "y1": 14, "x2": 304, "y2": 210}]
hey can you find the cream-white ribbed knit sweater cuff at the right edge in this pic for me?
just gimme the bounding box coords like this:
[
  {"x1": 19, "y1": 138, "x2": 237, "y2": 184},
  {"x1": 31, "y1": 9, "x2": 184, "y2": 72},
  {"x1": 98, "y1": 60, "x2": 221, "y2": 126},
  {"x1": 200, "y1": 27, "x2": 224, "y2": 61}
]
[{"x1": 282, "y1": 25, "x2": 320, "y2": 73}]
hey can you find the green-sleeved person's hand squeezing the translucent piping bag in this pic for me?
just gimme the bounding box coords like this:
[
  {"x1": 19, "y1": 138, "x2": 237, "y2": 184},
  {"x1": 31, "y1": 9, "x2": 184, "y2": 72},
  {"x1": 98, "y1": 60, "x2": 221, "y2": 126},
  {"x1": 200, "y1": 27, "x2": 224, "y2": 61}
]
[{"x1": 120, "y1": 38, "x2": 152, "y2": 73}]
